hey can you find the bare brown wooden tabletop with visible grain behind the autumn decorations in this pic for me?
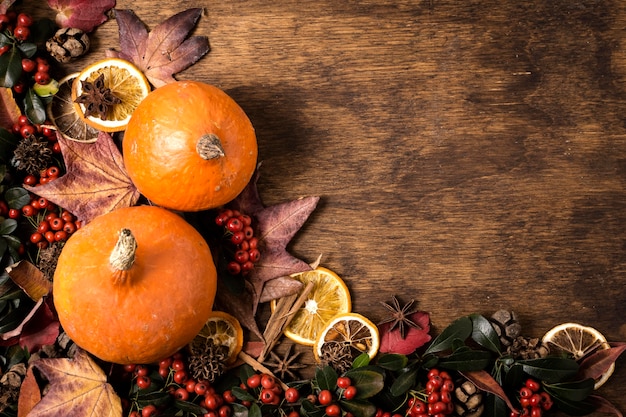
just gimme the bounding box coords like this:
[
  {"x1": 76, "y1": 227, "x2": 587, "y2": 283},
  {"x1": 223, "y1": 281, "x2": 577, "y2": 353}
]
[{"x1": 33, "y1": 0, "x2": 626, "y2": 411}]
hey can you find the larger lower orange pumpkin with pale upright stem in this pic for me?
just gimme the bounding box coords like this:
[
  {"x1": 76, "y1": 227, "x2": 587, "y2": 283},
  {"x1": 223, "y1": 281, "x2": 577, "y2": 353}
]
[{"x1": 53, "y1": 206, "x2": 217, "y2": 363}]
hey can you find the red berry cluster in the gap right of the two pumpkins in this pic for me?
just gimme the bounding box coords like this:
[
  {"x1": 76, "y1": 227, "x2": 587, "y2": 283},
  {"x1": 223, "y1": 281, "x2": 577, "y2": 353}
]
[{"x1": 215, "y1": 209, "x2": 261, "y2": 275}]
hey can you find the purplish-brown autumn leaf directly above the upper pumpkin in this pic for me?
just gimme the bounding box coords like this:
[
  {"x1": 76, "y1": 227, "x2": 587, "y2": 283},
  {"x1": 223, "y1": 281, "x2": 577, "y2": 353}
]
[{"x1": 115, "y1": 8, "x2": 210, "y2": 87}]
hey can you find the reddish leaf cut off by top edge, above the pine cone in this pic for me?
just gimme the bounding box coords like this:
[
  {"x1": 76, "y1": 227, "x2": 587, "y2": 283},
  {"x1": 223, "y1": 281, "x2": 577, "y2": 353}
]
[{"x1": 48, "y1": 0, "x2": 115, "y2": 32}]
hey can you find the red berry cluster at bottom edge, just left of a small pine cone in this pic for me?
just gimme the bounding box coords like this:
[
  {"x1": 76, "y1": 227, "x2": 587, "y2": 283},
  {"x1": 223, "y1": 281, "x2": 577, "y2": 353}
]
[{"x1": 407, "y1": 368, "x2": 454, "y2": 417}]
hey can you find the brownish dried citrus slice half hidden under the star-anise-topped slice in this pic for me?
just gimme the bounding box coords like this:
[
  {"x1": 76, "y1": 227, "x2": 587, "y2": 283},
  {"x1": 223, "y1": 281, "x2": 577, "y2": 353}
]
[{"x1": 46, "y1": 72, "x2": 98, "y2": 143}]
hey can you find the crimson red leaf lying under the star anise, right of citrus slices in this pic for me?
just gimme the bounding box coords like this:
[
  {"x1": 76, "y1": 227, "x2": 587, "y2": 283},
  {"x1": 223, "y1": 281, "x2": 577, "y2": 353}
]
[{"x1": 379, "y1": 311, "x2": 431, "y2": 355}]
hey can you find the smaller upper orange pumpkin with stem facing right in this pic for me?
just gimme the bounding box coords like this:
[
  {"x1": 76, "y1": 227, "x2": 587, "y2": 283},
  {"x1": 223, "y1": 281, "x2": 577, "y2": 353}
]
[{"x1": 123, "y1": 81, "x2": 258, "y2": 211}]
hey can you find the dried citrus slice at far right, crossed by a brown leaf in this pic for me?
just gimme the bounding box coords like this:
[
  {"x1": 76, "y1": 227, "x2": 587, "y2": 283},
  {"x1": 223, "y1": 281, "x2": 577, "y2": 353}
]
[{"x1": 541, "y1": 323, "x2": 615, "y2": 389}]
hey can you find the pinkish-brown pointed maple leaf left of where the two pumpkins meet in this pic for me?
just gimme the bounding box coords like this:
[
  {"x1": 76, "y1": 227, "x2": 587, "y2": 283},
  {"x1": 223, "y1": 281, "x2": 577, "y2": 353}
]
[{"x1": 25, "y1": 132, "x2": 140, "y2": 223}]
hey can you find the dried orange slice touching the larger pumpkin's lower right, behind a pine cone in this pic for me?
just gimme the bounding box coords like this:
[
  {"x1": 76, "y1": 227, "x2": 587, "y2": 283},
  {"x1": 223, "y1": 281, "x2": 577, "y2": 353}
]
[{"x1": 190, "y1": 311, "x2": 243, "y2": 365}]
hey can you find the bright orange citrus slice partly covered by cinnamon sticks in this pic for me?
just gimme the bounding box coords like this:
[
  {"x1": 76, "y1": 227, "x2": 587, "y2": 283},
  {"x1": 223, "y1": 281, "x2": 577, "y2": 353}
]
[{"x1": 271, "y1": 267, "x2": 352, "y2": 346}]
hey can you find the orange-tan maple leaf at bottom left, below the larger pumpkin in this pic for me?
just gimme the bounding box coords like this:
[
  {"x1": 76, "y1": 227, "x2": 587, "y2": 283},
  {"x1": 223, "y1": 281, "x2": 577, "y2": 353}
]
[{"x1": 28, "y1": 349, "x2": 122, "y2": 417}]
